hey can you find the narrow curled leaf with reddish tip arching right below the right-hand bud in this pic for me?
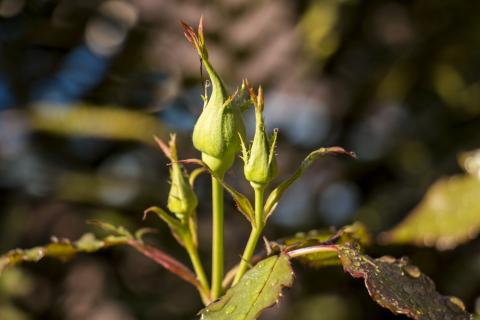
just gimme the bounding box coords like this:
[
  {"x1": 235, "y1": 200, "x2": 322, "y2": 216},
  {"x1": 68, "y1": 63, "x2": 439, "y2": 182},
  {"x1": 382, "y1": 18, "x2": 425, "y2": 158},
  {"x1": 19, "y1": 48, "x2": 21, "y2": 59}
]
[{"x1": 264, "y1": 147, "x2": 355, "y2": 220}]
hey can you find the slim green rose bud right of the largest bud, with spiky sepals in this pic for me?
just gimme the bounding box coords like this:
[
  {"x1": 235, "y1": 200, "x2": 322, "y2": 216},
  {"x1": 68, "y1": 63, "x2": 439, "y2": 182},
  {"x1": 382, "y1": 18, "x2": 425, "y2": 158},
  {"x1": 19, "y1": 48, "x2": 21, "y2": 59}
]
[{"x1": 242, "y1": 87, "x2": 277, "y2": 188}]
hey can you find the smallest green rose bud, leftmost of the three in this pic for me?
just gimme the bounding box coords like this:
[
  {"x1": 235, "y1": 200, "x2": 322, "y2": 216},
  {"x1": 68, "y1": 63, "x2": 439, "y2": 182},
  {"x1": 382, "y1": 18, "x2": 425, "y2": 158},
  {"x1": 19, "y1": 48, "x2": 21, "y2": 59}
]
[{"x1": 155, "y1": 134, "x2": 198, "y2": 222}]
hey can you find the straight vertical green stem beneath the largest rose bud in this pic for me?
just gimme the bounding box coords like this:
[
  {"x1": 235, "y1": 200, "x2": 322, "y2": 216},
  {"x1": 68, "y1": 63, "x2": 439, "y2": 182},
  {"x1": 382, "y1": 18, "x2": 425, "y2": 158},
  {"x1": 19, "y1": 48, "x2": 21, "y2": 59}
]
[{"x1": 212, "y1": 177, "x2": 223, "y2": 300}]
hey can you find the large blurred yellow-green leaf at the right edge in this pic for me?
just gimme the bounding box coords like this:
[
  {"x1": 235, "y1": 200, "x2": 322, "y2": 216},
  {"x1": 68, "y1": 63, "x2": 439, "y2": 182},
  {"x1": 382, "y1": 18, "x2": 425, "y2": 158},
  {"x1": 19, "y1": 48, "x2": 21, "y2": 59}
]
[{"x1": 380, "y1": 175, "x2": 480, "y2": 250}]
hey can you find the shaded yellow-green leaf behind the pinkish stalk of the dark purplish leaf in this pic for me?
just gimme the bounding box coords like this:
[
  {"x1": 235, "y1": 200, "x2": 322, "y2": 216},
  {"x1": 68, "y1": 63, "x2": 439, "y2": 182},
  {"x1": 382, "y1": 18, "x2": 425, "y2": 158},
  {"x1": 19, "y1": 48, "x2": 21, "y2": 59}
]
[{"x1": 283, "y1": 222, "x2": 371, "y2": 268}]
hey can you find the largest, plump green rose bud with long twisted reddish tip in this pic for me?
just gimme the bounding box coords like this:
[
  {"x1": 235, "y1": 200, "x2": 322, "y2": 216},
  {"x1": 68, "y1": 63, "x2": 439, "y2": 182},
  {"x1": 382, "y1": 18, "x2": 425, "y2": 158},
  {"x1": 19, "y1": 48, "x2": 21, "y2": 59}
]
[{"x1": 183, "y1": 19, "x2": 245, "y2": 176}]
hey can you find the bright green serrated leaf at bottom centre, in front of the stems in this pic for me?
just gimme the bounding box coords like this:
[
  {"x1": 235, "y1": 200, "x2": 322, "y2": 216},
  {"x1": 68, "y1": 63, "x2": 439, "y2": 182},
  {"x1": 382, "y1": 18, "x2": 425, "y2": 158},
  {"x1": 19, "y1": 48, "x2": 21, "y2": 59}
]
[{"x1": 201, "y1": 254, "x2": 293, "y2": 320}]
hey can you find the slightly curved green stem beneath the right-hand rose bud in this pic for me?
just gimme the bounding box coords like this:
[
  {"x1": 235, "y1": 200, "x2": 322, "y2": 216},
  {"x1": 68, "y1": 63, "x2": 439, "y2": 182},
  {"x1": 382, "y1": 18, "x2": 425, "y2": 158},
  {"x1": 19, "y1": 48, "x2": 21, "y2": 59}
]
[{"x1": 233, "y1": 187, "x2": 265, "y2": 285}]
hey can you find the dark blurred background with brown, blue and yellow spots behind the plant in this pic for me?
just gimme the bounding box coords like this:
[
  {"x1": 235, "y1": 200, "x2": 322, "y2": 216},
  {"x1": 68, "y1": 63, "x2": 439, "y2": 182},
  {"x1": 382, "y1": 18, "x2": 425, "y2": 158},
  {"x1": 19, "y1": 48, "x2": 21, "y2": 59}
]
[{"x1": 0, "y1": 0, "x2": 480, "y2": 320}]
